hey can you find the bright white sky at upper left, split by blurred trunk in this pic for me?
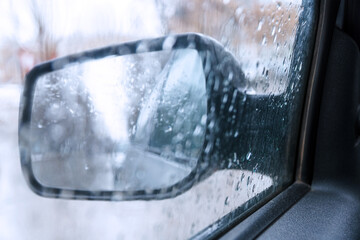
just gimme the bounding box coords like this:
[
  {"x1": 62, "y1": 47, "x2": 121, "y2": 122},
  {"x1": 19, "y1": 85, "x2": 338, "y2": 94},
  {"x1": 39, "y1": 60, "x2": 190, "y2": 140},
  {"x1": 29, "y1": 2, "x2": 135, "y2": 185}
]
[{"x1": 0, "y1": 0, "x2": 162, "y2": 45}]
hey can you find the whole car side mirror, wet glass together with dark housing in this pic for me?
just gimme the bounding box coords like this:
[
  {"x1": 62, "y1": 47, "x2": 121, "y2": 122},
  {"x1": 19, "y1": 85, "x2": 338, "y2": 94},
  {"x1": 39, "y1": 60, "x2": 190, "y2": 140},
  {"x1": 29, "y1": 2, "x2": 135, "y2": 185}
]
[{"x1": 19, "y1": 34, "x2": 245, "y2": 200}]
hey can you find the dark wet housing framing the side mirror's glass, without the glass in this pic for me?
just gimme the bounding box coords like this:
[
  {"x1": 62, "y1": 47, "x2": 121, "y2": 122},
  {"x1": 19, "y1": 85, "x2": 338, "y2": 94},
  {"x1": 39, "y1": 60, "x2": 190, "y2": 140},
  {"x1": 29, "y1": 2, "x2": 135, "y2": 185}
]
[{"x1": 19, "y1": 33, "x2": 246, "y2": 201}]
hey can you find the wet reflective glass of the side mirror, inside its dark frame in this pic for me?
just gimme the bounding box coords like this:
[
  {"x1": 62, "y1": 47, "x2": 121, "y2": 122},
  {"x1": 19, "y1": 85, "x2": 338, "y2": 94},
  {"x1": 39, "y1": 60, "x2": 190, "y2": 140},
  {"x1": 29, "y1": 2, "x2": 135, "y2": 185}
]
[{"x1": 30, "y1": 49, "x2": 207, "y2": 191}]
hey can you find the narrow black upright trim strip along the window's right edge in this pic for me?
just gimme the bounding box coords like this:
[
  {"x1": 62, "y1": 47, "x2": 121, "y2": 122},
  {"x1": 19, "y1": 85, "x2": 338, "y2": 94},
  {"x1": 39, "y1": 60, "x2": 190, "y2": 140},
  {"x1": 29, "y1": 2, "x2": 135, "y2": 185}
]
[{"x1": 296, "y1": 0, "x2": 340, "y2": 184}]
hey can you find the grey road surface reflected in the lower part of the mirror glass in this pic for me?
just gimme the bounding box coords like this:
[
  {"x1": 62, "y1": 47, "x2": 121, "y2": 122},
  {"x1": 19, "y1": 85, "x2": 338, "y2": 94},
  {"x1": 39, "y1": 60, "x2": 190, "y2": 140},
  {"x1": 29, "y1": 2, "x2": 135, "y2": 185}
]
[{"x1": 32, "y1": 147, "x2": 196, "y2": 191}]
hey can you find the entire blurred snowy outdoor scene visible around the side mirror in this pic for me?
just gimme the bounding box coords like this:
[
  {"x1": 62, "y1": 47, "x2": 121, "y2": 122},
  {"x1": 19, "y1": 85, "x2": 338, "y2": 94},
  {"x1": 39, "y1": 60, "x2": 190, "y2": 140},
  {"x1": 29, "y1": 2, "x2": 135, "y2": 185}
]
[{"x1": 0, "y1": 0, "x2": 302, "y2": 239}]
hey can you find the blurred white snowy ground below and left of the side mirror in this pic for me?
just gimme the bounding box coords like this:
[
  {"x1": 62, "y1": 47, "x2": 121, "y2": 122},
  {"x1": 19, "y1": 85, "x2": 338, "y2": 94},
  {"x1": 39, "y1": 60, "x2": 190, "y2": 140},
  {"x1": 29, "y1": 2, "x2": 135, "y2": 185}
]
[{"x1": 0, "y1": 85, "x2": 272, "y2": 240}]
